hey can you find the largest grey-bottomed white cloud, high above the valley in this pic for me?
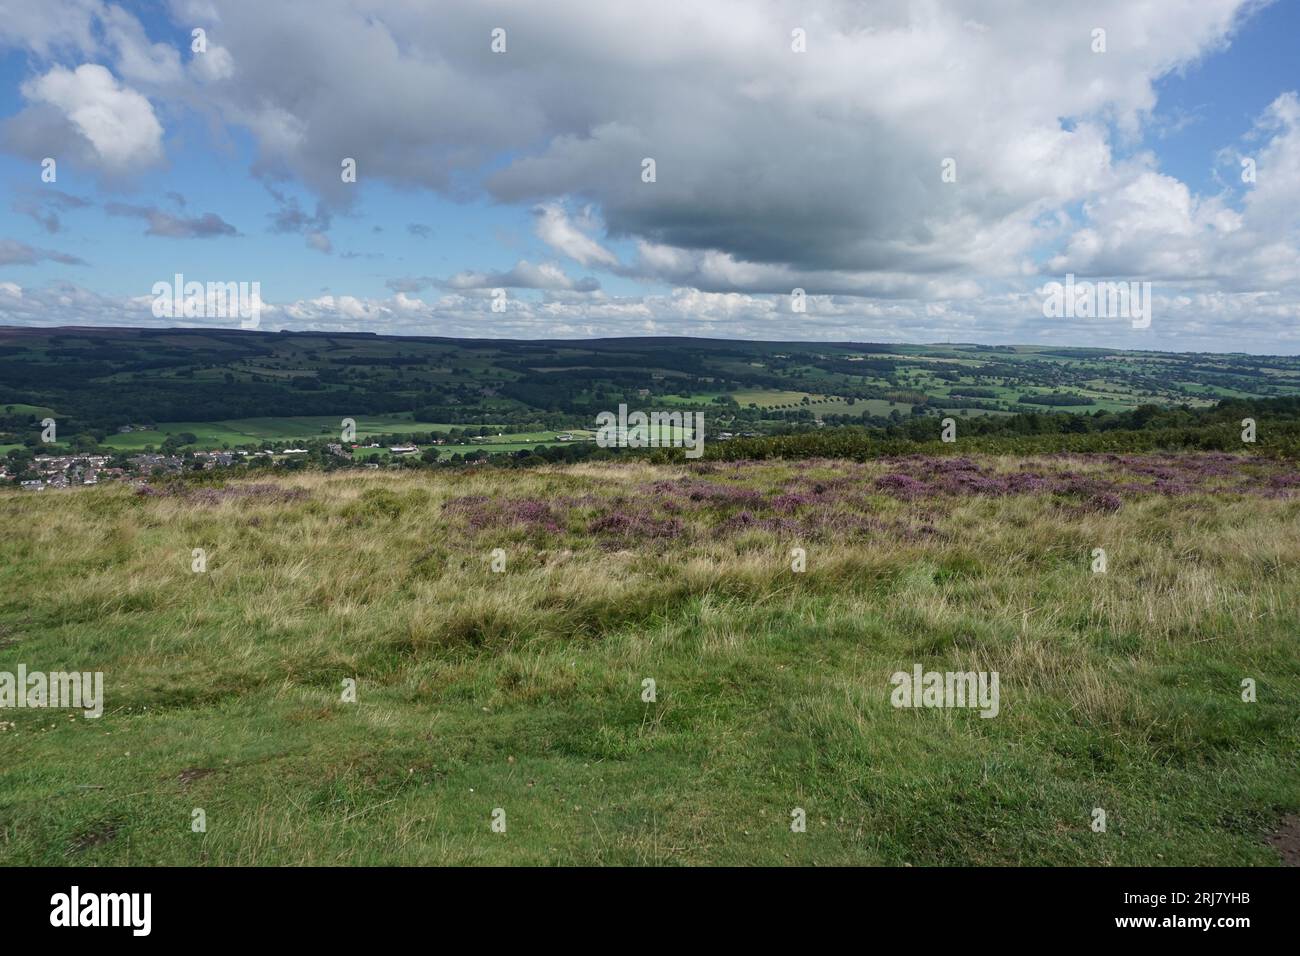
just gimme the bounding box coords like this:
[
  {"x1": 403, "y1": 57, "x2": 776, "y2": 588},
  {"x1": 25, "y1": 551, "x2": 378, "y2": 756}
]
[{"x1": 131, "y1": 0, "x2": 1279, "y2": 295}]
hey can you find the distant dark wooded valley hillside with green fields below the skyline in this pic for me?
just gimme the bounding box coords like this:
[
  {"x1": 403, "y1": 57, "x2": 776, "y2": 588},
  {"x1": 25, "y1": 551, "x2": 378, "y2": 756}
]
[{"x1": 0, "y1": 328, "x2": 1300, "y2": 462}]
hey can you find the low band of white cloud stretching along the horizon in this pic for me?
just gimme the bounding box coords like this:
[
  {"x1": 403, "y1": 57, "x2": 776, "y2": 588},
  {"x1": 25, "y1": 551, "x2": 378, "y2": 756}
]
[{"x1": 0, "y1": 282, "x2": 1300, "y2": 355}]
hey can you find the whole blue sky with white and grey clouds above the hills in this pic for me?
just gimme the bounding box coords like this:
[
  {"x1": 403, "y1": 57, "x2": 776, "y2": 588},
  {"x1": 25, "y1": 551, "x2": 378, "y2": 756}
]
[{"x1": 0, "y1": 0, "x2": 1300, "y2": 354}]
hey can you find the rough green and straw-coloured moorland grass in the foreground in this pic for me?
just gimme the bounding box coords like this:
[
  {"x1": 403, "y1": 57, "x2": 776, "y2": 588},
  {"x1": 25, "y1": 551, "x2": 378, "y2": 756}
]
[{"x1": 0, "y1": 464, "x2": 1300, "y2": 865}]
